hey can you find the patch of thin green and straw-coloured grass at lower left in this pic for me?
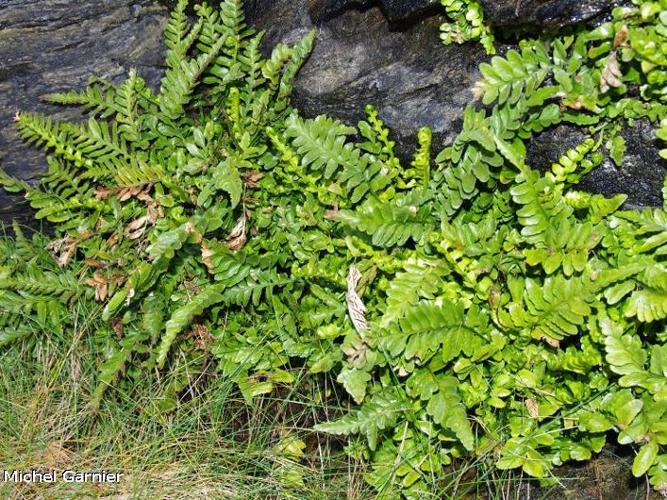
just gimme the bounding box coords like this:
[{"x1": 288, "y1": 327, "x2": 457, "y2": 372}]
[{"x1": 0, "y1": 356, "x2": 369, "y2": 498}]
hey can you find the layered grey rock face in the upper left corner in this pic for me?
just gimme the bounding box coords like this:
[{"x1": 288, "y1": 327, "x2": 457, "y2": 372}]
[{"x1": 0, "y1": 0, "x2": 167, "y2": 227}]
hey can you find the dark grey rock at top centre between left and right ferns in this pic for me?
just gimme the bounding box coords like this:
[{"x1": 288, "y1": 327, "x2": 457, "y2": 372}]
[{"x1": 246, "y1": 0, "x2": 487, "y2": 154}]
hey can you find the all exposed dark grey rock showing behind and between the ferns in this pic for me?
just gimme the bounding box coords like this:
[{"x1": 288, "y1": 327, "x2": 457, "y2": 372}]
[{"x1": 0, "y1": 0, "x2": 664, "y2": 227}]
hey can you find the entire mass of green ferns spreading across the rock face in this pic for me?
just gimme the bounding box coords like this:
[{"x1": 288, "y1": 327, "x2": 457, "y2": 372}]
[{"x1": 0, "y1": 0, "x2": 667, "y2": 498}]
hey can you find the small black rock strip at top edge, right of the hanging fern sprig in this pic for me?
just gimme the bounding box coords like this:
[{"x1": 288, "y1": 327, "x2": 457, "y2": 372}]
[{"x1": 480, "y1": 0, "x2": 614, "y2": 29}]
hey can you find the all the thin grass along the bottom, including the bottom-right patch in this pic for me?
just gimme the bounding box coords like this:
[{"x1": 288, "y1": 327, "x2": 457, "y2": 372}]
[{"x1": 0, "y1": 304, "x2": 647, "y2": 500}]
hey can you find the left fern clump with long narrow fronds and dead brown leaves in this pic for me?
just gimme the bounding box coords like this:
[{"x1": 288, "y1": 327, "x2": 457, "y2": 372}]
[{"x1": 2, "y1": 0, "x2": 313, "y2": 406}]
